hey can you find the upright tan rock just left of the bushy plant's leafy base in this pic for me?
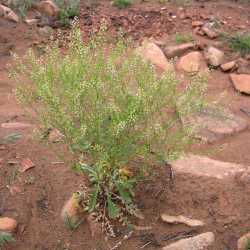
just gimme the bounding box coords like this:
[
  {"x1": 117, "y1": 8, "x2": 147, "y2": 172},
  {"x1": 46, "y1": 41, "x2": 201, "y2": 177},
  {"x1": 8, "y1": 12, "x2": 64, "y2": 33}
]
[{"x1": 61, "y1": 193, "x2": 82, "y2": 223}]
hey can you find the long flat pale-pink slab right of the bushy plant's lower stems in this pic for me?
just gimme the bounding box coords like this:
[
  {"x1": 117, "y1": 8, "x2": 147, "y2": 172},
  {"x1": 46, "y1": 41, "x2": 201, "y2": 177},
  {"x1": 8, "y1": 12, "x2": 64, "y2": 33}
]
[{"x1": 172, "y1": 154, "x2": 248, "y2": 180}]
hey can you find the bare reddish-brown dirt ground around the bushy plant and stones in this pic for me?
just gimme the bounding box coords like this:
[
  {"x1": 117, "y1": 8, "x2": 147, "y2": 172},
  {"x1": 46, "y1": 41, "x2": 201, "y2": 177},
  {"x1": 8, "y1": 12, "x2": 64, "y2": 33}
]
[{"x1": 0, "y1": 1, "x2": 250, "y2": 250}]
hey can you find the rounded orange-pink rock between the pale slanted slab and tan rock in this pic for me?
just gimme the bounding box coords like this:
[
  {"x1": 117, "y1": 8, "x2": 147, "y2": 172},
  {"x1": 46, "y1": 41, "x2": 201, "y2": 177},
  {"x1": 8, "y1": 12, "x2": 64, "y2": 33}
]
[{"x1": 177, "y1": 51, "x2": 207, "y2": 73}]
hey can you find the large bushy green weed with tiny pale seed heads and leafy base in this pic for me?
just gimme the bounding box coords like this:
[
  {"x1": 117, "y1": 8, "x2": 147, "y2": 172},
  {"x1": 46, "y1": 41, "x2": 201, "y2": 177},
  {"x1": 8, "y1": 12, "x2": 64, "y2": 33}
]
[{"x1": 14, "y1": 23, "x2": 205, "y2": 230}]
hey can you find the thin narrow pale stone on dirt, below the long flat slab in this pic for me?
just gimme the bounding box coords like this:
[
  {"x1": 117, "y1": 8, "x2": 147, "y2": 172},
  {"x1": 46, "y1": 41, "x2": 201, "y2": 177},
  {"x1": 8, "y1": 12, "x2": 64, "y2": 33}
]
[{"x1": 161, "y1": 214, "x2": 204, "y2": 227}]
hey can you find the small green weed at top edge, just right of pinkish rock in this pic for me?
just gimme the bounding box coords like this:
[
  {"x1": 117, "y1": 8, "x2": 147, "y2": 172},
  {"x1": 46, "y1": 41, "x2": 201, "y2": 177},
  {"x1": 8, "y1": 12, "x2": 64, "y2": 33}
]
[{"x1": 55, "y1": 0, "x2": 80, "y2": 27}]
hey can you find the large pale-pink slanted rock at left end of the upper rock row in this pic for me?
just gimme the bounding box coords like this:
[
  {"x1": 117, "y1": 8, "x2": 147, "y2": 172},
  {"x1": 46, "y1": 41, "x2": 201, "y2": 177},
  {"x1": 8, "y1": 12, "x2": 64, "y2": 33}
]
[{"x1": 136, "y1": 41, "x2": 173, "y2": 71}]
